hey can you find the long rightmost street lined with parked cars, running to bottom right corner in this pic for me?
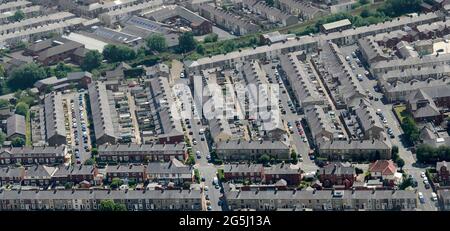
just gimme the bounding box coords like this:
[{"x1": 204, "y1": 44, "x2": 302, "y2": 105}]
[{"x1": 341, "y1": 45, "x2": 438, "y2": 211}]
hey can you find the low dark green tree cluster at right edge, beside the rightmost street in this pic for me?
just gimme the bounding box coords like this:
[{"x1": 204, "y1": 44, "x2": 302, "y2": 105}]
[{"x1": 416, "y1": 144, "x2": 450, "y2": 164}]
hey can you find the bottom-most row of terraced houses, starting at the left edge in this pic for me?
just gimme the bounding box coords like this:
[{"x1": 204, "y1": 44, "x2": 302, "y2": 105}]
[{"x1": 0, "y1": 189, "x2": 203, "y2": 211}]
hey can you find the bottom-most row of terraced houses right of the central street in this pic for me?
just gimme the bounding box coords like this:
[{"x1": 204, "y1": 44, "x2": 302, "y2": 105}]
[{"x1": 225, "y1": 190, "x2": 418, "y2": 211}]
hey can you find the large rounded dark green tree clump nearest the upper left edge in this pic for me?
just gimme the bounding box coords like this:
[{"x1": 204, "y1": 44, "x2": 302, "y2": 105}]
[{"x1": 7, "y1": 63, "x2": 47, "y2": 90}]
